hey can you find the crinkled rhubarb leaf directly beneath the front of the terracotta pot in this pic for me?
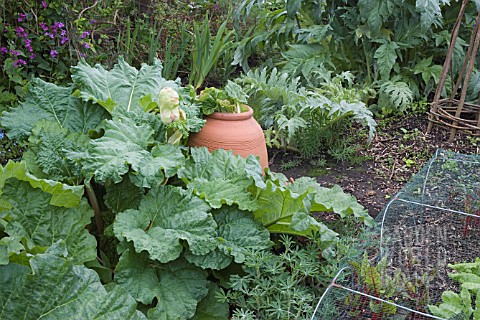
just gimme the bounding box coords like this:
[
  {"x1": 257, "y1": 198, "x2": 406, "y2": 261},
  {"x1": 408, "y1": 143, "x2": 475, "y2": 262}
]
[{"x1": 178, "y1": 148, "x2": 256, "y2": 211}]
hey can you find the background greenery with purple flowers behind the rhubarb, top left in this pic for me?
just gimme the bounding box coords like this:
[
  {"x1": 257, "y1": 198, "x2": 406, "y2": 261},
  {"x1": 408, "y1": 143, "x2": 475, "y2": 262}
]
[{"x1": 0, "y1": 0, "x2": 236, "y2": 111}]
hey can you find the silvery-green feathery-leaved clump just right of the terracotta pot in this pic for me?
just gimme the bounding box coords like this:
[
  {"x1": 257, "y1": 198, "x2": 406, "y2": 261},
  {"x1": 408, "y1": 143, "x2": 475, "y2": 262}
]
[{"x1": 237, "y1": 69, "x2": 376, "y2": 160}]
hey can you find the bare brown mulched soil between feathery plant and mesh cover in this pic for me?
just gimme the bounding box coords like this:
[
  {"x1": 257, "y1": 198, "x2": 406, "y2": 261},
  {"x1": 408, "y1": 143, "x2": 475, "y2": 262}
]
[{"x1": 269, "y1": 114, "x2": 480, "y2": 217}]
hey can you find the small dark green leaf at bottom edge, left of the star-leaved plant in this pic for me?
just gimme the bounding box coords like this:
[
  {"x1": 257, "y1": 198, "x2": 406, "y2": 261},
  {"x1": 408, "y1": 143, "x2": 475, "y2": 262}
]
[{"x1": 192, "y1": 282, "x2": 230, "y2": 320}]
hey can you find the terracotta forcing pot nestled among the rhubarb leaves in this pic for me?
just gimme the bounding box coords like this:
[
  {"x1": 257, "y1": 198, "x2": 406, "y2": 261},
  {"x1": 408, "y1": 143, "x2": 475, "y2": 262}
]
[{"x1": 188, "y1": 107, "x2": 268, "y2": 169}]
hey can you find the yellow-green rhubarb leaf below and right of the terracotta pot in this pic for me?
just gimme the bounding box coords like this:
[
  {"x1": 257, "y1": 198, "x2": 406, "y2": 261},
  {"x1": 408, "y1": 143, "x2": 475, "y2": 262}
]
[{"x1": 254, "y1": 181, "x2": 337, "y2": 242}]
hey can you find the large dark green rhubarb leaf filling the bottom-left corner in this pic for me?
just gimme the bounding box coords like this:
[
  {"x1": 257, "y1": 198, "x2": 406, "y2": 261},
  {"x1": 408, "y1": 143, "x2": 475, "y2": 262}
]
[{"x1": 0, "y1": 244, "x2": 145, "y2": 320}]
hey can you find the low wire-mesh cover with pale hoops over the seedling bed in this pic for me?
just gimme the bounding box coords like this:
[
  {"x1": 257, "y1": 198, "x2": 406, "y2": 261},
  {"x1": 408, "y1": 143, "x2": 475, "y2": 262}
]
[{"x1": 311, "y1": 149, "x2": 480, "y2": 320}]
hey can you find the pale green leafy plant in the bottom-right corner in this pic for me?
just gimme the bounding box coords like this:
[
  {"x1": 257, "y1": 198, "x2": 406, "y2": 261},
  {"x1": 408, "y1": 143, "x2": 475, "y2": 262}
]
[{"x1": 428, "y1": 258, "x2": 480, "y2": 320}]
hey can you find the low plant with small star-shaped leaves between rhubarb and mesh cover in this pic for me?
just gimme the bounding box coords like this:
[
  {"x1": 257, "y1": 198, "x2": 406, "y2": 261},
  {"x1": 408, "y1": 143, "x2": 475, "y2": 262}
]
[{"x1": 218, "y1": 236, "x2": 338, "y2": 319}]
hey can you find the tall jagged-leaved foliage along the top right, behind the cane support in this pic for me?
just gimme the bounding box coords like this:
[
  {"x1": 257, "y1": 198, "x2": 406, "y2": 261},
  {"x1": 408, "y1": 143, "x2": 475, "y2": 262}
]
[{"x1": 234, "y1": 0, "x2": 479, "y2": 114}]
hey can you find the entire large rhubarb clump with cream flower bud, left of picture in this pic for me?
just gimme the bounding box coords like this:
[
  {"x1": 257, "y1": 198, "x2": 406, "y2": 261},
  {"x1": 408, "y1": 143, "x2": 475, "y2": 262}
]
[{"x1": 0, "y1": 59, "x2": 372, "y2": 319}]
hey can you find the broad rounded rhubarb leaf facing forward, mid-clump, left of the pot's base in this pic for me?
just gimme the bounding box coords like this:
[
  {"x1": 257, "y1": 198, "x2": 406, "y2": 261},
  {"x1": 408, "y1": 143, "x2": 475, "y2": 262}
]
[{"x1": 113, "y1": 186, "x2": 217, "y2": 263}]
